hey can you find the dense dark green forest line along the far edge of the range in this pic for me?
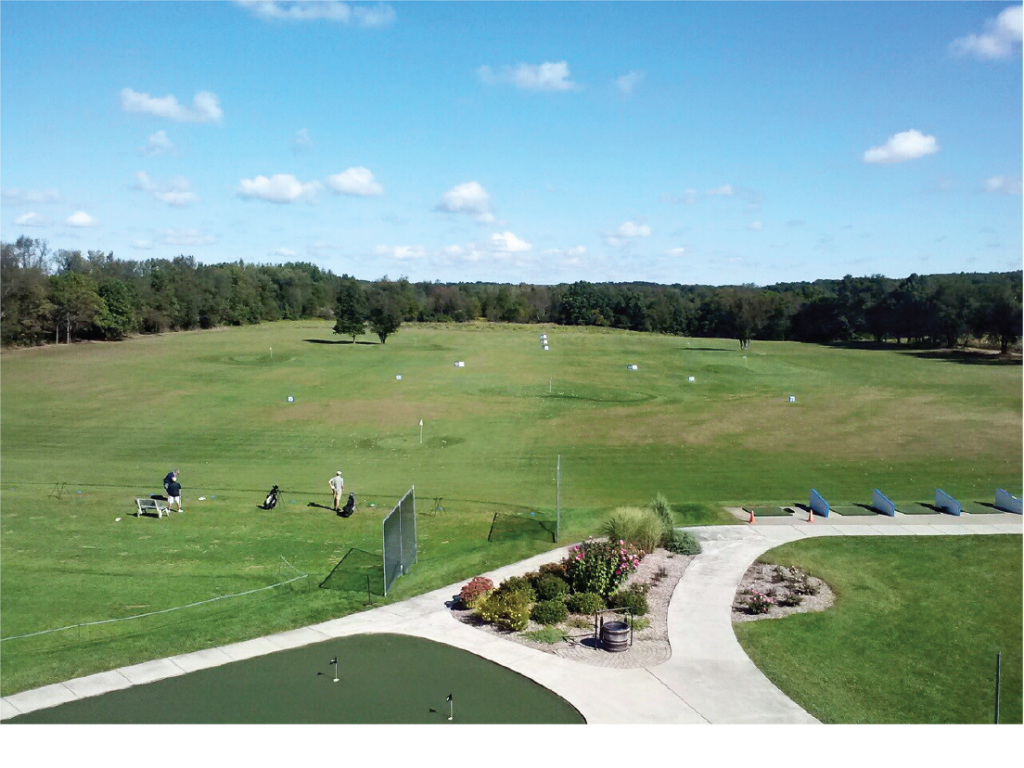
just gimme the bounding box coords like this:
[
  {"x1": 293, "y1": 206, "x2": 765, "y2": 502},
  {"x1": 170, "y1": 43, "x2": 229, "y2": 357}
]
[{"x1": 0, "y1": 238, "x2": 1024, "y2": 353}]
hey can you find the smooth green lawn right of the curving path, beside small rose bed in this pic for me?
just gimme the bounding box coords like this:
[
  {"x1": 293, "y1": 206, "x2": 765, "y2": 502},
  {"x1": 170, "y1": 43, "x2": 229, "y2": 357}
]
[{"x1": 736, "y1": 537, "x2": 1024, "y2": 725}]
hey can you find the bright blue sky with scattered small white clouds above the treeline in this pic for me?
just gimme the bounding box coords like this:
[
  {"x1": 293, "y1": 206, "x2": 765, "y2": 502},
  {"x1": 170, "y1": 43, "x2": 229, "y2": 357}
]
[{"x1": 0, "y1": 0, "x2": 1024, "y2": 284}]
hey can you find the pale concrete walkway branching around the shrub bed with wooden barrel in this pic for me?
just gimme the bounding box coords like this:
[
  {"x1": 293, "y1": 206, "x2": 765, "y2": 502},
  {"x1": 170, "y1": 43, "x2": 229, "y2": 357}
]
[{"x1": 0, "y1": 515, "x2": 1024, "y2": 725}]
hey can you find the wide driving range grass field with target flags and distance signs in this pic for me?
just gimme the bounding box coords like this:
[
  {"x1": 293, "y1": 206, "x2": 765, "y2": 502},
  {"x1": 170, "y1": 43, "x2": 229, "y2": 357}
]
[{"x1": 0, "y1": 322, "x2": 1024, "y2": 694}]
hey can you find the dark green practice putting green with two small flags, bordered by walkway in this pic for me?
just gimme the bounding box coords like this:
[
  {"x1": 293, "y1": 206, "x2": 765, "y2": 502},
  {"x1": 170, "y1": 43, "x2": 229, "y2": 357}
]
[{"x1": 10, "y1": 635, "x2": 586, "y2": 725}]
